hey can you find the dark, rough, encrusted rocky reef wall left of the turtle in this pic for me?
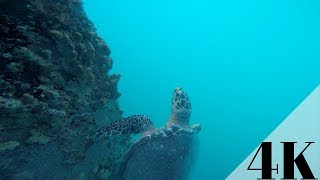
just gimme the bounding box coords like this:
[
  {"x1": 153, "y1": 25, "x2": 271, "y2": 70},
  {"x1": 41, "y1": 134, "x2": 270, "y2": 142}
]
[{"x1": 0, "y1": 0, "x2": 130, "y2": 179}]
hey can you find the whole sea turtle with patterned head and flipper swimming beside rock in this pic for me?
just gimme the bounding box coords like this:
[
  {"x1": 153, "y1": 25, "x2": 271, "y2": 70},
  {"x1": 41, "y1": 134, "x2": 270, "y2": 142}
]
[{"x1": 88, "y1": 88, "x2": 201, "y2": 180}]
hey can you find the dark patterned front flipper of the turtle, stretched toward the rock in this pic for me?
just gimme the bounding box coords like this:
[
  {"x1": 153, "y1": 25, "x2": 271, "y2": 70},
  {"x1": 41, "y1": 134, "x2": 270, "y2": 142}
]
[{"x1": 88, "y1": 115, "x2": 154, "y2": 139}]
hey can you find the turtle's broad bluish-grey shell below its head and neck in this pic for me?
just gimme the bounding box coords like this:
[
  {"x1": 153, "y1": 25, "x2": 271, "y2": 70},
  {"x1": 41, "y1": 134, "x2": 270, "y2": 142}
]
[{"x1": 119, "y1": 127, "x2": 199, "y2": 180}]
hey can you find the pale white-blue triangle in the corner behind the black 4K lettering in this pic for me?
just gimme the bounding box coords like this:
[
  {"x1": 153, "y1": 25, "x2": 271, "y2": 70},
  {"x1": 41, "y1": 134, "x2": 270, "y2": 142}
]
[{"x1": 226, "y1": 86, "x2": 320, "y2": 180}]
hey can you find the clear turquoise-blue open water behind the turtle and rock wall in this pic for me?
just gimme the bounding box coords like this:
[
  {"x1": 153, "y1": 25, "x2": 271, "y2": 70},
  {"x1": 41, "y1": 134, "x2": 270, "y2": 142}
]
[{"x1": 84, "y1": 0, "x2": 320, "y2": 179}]
